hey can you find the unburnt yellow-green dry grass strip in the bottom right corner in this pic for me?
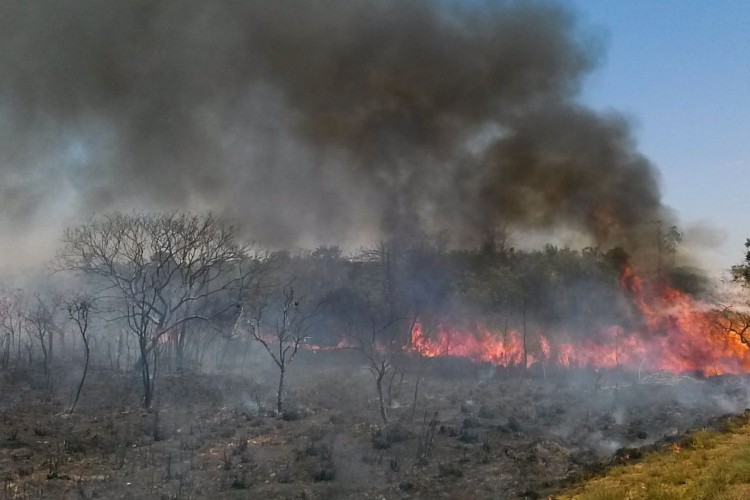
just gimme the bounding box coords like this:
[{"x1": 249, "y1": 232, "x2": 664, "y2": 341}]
[{"x1": 557, "y1": 417, "x2": 750, "y2": 500}]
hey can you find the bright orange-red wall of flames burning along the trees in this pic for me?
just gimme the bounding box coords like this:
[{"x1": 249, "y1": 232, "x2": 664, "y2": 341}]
[{"x1": 409, "y1": 267, "x2": 750, "y2": 375}]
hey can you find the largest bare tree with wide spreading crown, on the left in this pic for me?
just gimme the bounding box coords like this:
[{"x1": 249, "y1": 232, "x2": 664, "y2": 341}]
[{"x1": 57, "y1": 212, "x2": 262, "y2": 407}]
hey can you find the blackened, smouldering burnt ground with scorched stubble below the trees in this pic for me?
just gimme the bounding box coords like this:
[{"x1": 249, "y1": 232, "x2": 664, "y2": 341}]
[{"x1": 0, "y1": 352, "x2": 748, "y2": 499}]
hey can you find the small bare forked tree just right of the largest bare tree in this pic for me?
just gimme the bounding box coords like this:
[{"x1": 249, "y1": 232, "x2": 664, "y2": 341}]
[{"x1": 250, "y1": 281, "x2": 320, "y2": 413}]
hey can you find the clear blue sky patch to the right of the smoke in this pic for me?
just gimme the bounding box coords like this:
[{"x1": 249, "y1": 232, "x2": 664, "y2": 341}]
[{"x1": 565, "y1": 0, "x2": 750, "y2": 271}]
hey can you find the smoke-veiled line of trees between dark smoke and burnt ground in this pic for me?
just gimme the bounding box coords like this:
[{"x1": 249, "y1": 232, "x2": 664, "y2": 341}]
[{"x1": 0, "y1": 213, "x2": 700, "y2": 420}]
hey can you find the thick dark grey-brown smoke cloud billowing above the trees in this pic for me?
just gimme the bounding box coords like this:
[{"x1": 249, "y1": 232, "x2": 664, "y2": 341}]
[{"x1": 0, "y1": 0, "x2": 665, "y2": 256}]
